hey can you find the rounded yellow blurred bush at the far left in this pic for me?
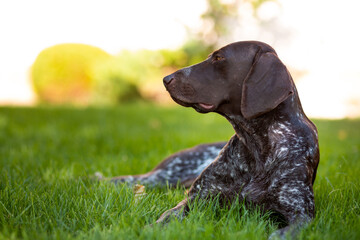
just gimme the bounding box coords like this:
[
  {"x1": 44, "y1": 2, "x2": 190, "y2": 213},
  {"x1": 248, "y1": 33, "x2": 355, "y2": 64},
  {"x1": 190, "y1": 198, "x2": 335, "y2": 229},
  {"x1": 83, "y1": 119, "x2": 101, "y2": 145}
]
[{"x1": 31, "y1": 44, "x2": 111, "y2": 104}]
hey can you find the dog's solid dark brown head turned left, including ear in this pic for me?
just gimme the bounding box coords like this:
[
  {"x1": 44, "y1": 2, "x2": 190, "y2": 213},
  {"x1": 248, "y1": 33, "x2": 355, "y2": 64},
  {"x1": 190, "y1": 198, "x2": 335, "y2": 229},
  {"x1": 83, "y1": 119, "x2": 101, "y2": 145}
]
[{"x1": 164, "y1": 41, "x2": 294, "y2": 119}]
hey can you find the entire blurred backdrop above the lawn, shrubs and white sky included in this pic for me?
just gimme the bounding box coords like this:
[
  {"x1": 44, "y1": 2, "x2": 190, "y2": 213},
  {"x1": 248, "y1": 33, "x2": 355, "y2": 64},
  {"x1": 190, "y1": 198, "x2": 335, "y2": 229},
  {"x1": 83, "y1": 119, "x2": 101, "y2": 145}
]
[{"x1": 0, "y1": 0, "x2": 360, "y2": 118}]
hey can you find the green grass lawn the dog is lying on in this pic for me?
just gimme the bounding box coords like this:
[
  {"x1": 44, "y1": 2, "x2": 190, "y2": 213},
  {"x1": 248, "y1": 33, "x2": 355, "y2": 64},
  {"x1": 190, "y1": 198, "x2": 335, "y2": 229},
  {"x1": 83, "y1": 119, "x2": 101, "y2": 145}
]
[{"x1": 0, "y1": 104, "x2": 360, "y2": 240}]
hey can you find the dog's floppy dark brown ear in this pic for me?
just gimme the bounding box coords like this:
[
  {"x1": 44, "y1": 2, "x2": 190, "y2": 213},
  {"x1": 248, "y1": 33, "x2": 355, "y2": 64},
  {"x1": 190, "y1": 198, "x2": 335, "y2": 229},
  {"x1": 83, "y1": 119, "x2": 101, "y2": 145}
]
[{"x1": 241, "y1": 51, "x2": 293, "y2": 119}]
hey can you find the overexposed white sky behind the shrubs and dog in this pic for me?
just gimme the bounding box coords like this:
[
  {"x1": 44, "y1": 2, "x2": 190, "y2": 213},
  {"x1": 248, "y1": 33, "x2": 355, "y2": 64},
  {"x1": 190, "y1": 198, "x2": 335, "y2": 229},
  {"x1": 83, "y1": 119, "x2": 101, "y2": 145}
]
[{"x1": 0, "y1": 0, "x2": 360, "y2": 118}]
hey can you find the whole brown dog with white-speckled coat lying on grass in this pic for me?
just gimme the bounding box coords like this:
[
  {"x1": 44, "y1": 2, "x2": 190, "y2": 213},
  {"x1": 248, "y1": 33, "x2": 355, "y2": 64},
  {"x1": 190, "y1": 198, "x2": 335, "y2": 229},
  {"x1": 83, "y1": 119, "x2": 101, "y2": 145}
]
[{"x1": 109, "y1": 41, "x2": 319, "y2": 236}]
